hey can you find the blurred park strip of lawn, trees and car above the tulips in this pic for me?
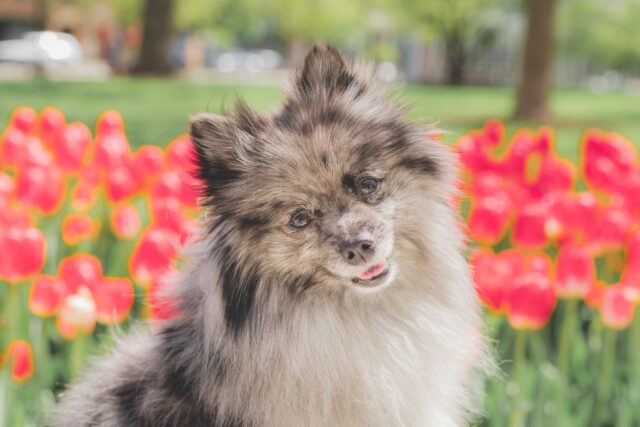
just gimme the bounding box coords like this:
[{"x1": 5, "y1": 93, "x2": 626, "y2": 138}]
[{"x1": 0, "y1": 0, "x2": 640, "y2": 144}]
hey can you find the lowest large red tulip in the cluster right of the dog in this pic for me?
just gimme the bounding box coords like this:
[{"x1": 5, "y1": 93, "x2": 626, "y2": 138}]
[{"x1": 506, "y1": 272, "x2": 556, "y2": 330}]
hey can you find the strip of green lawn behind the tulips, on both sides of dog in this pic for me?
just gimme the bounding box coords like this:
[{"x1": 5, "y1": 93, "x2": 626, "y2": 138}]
[{"x1": 0, "y1": 78, "x2": 640, "y2": 157}]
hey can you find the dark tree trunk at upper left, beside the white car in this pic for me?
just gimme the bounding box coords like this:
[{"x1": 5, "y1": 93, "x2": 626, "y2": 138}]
[{"x1": 133, "y1": 0, "x2": 174, "y2": 74}]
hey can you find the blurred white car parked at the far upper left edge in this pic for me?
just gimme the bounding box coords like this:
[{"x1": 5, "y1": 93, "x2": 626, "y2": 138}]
[{"x1": 0, "y1": 31, "x2": 82, "y2": 65}]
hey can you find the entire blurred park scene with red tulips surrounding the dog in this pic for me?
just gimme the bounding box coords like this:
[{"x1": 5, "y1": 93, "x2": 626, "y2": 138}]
[{"x1": 0, "y1": 0, "x2": 640, "y2": 427}]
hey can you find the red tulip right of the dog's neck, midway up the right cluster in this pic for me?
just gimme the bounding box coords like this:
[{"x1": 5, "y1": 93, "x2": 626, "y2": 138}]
[{"x1": 469, "y1": 192, "x2": 511, "y2": 244}]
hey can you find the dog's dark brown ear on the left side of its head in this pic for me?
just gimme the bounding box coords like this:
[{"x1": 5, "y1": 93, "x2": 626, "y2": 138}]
[{"x1": 189, "y1": 103, "x2": 266, "y2": 196}]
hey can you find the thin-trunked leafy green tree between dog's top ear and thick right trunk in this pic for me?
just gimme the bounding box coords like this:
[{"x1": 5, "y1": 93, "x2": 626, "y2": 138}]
[{"x1": 396, "y1": 0, "x2": 497, "y2": 85}]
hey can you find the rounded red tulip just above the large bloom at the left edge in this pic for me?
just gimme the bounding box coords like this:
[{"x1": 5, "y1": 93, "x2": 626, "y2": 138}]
[{"x1": 16, "y1": 166, "x2": 65, "y2": 214}]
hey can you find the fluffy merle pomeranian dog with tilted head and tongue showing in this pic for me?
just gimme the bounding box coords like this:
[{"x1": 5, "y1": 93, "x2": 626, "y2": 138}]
[{"x1": 54, "y1": 44, "x2": 491, "y2": 427}]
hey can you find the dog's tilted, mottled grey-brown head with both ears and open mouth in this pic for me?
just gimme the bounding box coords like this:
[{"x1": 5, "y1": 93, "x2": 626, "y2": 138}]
[{"x1": 191, "y1": 45, "x2": 450, "y2": 328}]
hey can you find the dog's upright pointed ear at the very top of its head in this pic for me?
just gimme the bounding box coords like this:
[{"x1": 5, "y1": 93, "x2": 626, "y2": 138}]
[{"x1": 295, "y1": 43, "x2": 355, "y2": 102}]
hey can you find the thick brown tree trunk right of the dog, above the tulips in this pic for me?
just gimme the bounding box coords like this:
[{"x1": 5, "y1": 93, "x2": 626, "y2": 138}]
[{"x1": 514, "y1": 0, "x2": 555, "y2": 120}]
